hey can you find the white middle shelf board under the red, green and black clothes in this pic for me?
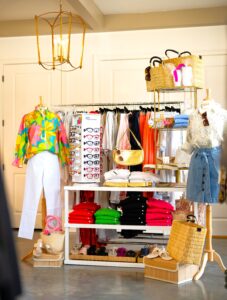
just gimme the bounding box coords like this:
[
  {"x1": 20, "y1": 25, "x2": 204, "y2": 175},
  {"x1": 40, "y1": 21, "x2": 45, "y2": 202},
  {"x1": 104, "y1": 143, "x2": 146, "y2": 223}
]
[{"x1": 65, "y1": 223, "x2": 171, "y2": 235}]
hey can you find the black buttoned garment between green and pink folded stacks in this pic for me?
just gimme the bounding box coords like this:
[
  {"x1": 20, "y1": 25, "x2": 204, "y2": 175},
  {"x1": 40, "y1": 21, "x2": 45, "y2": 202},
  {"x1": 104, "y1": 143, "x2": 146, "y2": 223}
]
[{"x1": 121, "y1": 193, "x2": 146, "y2": 225}]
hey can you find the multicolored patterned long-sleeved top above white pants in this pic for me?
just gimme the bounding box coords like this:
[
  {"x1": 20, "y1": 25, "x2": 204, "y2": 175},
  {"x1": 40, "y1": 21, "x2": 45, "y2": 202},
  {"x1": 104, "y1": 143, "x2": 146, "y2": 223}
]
[{"x1": 13, "y1": 106, "x2": 69, "y2": 167}]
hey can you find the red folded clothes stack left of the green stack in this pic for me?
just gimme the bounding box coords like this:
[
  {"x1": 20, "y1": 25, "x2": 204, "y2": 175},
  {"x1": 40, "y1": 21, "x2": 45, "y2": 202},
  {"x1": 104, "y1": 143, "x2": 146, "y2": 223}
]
[{"x1": 69, "y1": 202, "x2": 100, "y2": 224}]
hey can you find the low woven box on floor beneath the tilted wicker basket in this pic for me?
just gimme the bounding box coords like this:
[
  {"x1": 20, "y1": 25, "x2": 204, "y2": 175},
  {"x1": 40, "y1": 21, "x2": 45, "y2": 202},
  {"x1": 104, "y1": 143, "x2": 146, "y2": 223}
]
[{"x1": 144, "y1": 257, "x2": 199, "y2": 284}]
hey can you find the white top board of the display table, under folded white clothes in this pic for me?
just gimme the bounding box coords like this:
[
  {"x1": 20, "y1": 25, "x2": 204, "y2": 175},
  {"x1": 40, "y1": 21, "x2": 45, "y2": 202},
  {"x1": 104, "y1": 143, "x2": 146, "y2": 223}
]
[{"x1": 64, "y1": 184, "x2": 186, "y2": 192}]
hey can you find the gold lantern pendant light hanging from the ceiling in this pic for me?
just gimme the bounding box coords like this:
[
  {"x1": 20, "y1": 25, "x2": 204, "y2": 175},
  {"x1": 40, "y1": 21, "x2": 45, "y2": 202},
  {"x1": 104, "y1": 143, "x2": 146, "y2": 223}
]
[{"x1": 35, "y1": 1, "x2": 86, "y2": 72}]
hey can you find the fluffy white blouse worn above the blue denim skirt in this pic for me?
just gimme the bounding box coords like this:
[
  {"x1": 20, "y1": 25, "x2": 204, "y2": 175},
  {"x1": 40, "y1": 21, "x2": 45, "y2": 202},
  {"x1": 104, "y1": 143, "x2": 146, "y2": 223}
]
[{"x1": 182, "y1": 100, "x2": 227, "y2": 153}]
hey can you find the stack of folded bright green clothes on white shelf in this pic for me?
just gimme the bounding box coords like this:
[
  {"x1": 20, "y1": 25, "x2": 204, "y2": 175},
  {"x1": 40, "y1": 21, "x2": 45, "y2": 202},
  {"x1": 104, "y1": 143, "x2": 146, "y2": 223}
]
[{"x1": 95, "y1": 208, "x2": 121, "y2": 225}]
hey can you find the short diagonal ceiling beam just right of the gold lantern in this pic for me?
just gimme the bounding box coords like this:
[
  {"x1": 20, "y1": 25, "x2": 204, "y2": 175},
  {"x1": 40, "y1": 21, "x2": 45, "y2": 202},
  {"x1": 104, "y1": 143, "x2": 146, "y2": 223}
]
[{"x1": 66, "y1": 0, "x2": 104, "y2": 31}]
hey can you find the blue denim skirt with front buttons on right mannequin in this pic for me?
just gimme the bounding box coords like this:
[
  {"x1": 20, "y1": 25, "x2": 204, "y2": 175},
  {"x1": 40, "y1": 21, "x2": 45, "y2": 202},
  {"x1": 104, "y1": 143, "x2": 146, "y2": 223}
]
[{"x1": 186, "y1": 147, "x2": 221, "y2": 203}]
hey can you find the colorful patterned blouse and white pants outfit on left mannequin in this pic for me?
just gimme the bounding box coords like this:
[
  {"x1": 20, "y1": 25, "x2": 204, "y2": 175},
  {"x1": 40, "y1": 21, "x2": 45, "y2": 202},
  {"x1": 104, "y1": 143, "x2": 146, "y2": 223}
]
[{"x1": 13, "y1": 98, "x2": 69, "y2": 239}]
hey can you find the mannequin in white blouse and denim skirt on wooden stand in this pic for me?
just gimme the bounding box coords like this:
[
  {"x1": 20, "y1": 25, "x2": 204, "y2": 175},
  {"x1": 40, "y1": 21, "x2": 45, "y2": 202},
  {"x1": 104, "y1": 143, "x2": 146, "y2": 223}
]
[{"x1": 183, "y1": 89, "x2": 227, "y2": 280}]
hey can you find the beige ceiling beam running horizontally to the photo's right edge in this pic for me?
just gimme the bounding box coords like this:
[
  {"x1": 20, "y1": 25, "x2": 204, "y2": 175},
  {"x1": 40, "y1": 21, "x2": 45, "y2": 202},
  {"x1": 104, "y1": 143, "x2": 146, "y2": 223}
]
[{"x1": 103, "y1": 6, "x2": 227, "y2": 31}]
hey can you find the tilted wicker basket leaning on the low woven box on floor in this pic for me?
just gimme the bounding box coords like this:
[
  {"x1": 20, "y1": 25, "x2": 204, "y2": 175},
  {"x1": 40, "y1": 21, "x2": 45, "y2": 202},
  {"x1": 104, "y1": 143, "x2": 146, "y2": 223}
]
[{"x1": 167, "y1": 220, "x2": 206, "y2": 265}]
